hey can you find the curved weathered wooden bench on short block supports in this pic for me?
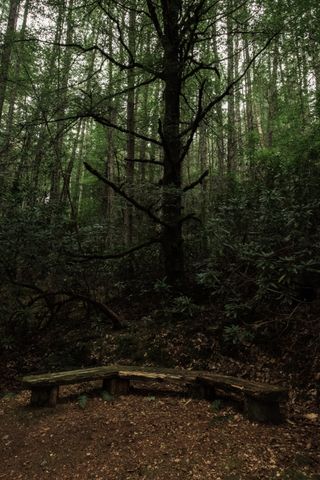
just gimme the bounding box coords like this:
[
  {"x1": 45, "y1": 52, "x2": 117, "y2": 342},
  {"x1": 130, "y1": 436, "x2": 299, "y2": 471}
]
[{"x1": 22, "y1": 365, "x2": 287, "y2": 423}]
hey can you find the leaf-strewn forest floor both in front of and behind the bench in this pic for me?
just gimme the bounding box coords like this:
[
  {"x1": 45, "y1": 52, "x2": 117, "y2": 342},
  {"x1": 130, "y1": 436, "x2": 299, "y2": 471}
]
[{"x1": 0, "y1": 288, "x2": 320, "y2": 480}]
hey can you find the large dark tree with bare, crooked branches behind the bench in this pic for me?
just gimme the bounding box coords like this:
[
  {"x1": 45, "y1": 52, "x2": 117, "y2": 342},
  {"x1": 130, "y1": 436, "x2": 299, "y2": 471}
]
[{"x1": 53, "y1": 0, "x2": 273, "y2": 284}]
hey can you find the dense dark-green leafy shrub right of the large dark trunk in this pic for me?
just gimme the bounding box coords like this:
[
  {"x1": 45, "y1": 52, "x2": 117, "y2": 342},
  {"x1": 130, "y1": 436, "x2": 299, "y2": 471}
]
[{"x1": 197, "y1": 139, "x2": 320, "y2": 332}]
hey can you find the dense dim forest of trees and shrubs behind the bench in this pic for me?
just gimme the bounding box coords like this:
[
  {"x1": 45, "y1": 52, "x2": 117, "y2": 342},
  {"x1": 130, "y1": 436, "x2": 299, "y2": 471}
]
[{"x1": 0, "y1": 0, "x2": 320, "y2": 396}]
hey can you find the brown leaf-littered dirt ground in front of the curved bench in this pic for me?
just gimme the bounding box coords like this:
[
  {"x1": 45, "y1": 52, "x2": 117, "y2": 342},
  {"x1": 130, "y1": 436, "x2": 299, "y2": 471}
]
[{"x1": 0, "y1": 385, "x2": 320, "y2": 480}]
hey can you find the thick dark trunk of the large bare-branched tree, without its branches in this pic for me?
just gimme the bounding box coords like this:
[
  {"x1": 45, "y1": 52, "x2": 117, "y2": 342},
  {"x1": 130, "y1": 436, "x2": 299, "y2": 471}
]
[{"x1": 161, "y1": 0, "x2": 184, "y2": 284}]
